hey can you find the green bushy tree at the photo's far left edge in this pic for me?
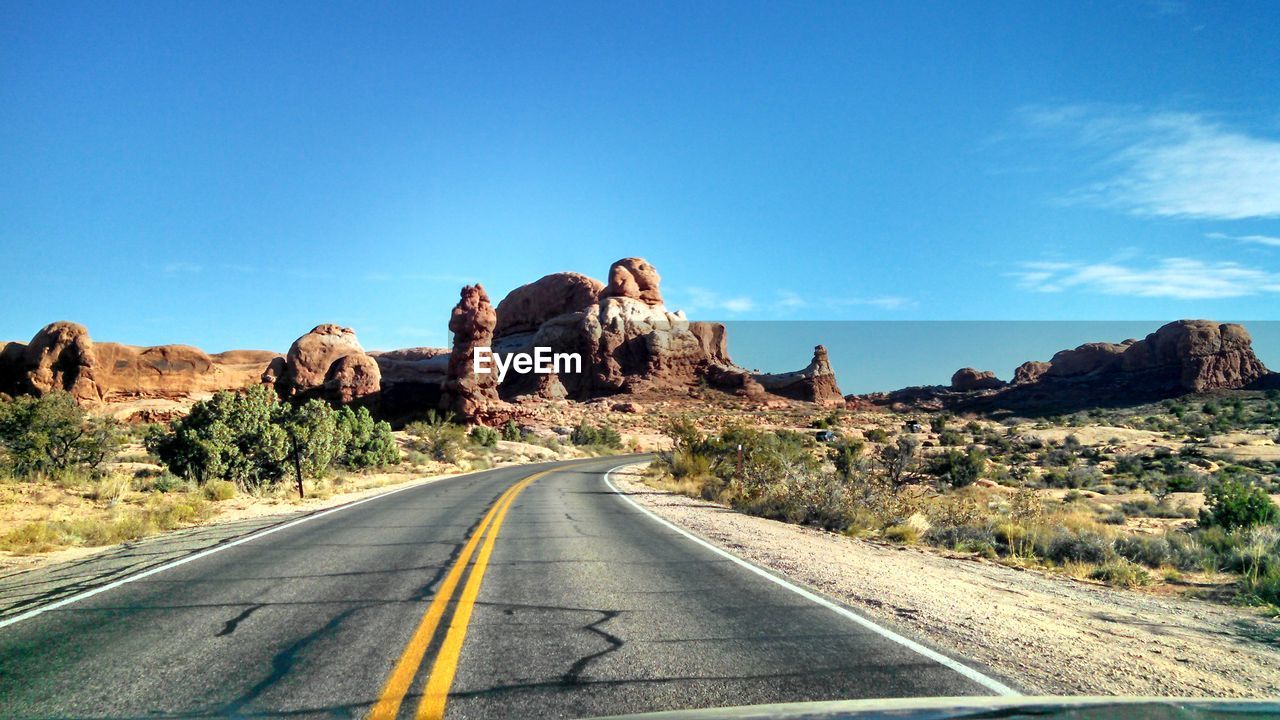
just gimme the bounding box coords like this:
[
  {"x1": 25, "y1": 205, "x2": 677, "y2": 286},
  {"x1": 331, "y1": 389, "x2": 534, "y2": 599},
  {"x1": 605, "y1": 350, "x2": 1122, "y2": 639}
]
[{"x1": 0, "y1": 391, "x2": 120, "y2": 474}]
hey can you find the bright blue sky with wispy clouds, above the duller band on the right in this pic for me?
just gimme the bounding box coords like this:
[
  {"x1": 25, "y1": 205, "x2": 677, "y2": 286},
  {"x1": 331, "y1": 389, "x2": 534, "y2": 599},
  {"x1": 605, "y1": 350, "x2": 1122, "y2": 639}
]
[{"x1": 0, "y1": 0, "x2": 1280, "y2": 386}]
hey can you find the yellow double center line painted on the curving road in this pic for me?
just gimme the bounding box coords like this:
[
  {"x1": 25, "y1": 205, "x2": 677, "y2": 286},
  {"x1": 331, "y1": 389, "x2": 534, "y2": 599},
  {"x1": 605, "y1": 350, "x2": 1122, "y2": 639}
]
[{"x1": 369, "y1": 470, "x2": 550, "y2": 720}]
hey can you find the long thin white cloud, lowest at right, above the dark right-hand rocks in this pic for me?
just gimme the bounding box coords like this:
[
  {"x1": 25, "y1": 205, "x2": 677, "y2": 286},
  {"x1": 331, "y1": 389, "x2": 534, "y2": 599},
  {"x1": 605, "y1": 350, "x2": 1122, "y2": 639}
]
[{"x1": 1009, "y1": 258, "x2": 1280, "y2": 300}]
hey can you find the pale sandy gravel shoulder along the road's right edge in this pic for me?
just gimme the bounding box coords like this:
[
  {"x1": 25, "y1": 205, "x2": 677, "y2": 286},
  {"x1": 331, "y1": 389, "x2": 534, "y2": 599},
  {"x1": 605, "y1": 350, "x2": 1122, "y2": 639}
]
[{"x1": 613, "y1": 465, "x2": 1280, "y2": 697}]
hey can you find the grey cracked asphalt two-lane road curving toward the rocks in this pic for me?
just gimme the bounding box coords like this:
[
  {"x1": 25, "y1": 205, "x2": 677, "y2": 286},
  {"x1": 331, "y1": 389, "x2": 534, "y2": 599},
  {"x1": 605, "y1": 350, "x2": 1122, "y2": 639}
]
[{"x1": 0, "y1": 459, "x2": 1018, "y2": 719}]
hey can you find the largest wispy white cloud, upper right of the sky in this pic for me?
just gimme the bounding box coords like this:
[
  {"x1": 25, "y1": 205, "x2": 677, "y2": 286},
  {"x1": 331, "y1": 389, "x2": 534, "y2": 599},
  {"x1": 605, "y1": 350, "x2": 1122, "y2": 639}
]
[{"x1": 1020, "y1": 105, "x2": 1280, "y2": 220}]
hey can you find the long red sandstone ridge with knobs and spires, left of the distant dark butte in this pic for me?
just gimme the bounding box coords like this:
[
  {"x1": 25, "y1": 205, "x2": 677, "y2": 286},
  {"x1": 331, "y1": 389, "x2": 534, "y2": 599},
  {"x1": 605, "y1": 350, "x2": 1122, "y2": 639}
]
[{"x1": 0, "y1": 258, "x2": 849, "y2": 421}]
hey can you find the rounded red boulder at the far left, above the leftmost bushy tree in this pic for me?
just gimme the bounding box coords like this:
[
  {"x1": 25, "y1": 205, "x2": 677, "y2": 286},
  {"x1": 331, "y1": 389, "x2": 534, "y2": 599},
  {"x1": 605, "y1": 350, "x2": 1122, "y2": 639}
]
[{"x1": 23, "y1": 320, "x2": 104, "y2": 405}]
